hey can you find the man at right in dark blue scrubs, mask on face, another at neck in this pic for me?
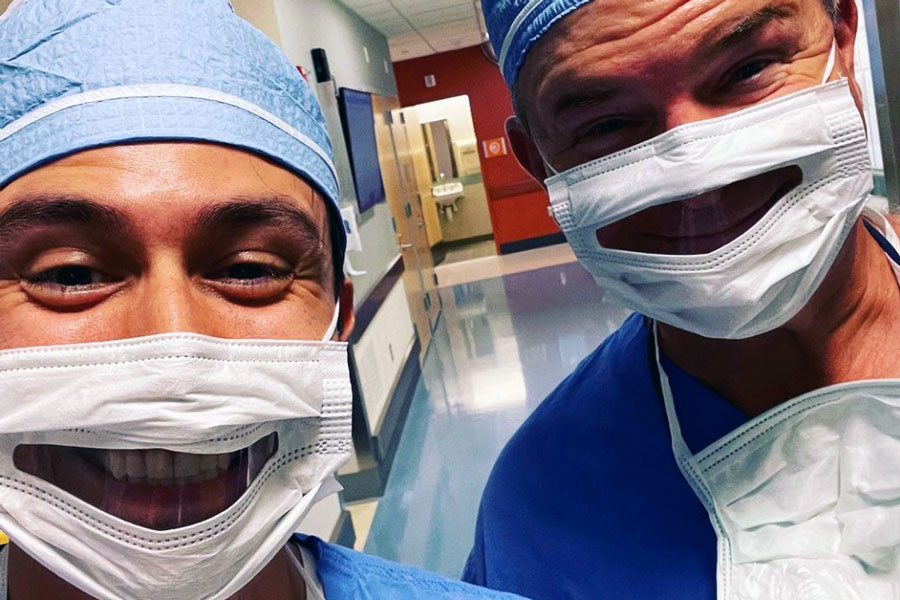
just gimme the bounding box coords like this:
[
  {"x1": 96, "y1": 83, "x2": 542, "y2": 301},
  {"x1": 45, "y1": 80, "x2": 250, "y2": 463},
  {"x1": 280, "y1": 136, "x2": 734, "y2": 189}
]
[{"x1": 464, "y1": 0, "x2": 900, "y2": 600}]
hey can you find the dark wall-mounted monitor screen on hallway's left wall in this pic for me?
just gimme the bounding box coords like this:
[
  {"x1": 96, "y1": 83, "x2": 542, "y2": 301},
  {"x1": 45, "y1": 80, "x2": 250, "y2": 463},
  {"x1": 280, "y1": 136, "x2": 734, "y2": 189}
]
[{"x1": 340, "y1": 88, "x2": 385, "y2": 213}]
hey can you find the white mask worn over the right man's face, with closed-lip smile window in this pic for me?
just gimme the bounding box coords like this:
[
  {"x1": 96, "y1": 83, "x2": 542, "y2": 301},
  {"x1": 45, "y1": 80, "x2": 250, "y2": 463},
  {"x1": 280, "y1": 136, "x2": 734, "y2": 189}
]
[{"x1": 547, "y1": 48, "x2": 872, "y2": 338}]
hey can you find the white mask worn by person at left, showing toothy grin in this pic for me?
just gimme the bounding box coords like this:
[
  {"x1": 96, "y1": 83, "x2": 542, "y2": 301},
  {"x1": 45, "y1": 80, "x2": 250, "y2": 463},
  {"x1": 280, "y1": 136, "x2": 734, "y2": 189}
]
[{"x1": 0, "y1": 310, "x2": 351, "y2": 600}]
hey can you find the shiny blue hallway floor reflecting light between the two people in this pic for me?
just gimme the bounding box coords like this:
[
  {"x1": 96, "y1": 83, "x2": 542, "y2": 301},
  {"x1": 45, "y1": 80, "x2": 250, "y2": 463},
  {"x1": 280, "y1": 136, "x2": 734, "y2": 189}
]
[{"x1": 365, "y1": 263, "x2": 627, "y2": 577}]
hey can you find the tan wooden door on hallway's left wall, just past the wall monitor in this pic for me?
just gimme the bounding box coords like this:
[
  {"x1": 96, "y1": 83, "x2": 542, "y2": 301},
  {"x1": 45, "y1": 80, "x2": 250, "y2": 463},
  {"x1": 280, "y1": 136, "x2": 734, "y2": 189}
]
[{"x1": 372, "y1": 94, "x2": 440, "y2": 356}]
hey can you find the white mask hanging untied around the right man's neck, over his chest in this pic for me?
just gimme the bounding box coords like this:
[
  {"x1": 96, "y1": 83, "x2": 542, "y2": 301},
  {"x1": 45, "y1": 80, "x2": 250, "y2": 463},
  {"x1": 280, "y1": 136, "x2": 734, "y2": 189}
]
[{"x1": 654, "y1": 212, "x2": 900, "y2": 600}]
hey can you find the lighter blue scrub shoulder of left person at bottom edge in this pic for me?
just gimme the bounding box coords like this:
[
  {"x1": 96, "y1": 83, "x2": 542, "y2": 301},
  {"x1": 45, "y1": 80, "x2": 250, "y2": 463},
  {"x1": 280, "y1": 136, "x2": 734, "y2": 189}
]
[{"x1": 295, "y1": 535, "x2": 523, "y2": 600}]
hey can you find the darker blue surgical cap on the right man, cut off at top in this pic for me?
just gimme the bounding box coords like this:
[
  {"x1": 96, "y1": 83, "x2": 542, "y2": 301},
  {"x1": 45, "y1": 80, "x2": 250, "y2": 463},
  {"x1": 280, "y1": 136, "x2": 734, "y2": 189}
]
[{"x1": 481, "y1": 0, "x2": 592, "y2": 88}]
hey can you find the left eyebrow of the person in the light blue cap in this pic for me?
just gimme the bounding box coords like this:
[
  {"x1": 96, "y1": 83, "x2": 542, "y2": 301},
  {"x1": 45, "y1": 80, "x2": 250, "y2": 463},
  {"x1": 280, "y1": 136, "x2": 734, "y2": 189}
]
[{"x1": 0, "y1": 195, "x2": 130, "y2": 247}]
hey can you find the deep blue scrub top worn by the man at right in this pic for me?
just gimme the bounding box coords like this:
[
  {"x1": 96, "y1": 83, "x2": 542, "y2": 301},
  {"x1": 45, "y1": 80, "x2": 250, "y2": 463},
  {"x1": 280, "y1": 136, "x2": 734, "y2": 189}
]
[{"x1": 463, "y1": 315, "x2": 747, "y2": 600}]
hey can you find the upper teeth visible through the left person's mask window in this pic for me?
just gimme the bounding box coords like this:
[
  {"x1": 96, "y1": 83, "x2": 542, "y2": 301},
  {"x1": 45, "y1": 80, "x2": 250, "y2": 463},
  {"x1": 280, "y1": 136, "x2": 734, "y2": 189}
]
[{"x1": 103, "y1": 449, "x2": 234, "y2": 485}]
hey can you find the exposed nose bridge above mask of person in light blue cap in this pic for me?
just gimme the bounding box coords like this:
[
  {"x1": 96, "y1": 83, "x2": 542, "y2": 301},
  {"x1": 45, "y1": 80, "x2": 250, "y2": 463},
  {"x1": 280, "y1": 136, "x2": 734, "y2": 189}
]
[{"x1": 129, "y1": 268, "x2": 218, "y2": 337}]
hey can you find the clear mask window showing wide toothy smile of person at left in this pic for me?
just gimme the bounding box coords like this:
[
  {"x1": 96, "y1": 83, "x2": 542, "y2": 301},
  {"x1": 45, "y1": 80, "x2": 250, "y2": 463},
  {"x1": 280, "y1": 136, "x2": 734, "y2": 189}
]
[{"x1": 13, "y1": 433, "x2": 278, "y2": 531}]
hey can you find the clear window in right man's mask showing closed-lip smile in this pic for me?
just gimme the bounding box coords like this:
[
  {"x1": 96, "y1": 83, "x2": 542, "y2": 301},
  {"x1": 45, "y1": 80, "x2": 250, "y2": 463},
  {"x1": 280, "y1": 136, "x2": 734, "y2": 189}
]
[{"x1": 597, "y1": 166, "x2": 803, "y2": 255}]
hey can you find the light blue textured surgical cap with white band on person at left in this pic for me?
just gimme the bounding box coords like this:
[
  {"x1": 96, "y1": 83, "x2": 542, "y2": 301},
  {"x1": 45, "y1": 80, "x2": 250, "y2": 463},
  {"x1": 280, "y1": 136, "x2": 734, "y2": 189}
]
[{"x1": 0, "y1": 0, "x2": 345, "y2": 255}]
